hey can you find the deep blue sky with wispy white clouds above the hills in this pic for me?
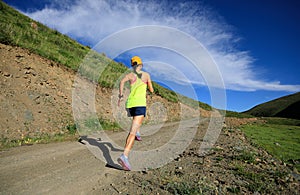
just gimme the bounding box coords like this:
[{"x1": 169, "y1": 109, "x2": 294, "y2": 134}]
[{"x1": 4, "y1": 0, "x2": 300, "y2": 111}]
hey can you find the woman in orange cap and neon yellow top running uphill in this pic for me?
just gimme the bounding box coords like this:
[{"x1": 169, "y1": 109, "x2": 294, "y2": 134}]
[{"x1": 118, "y1": 56, "x2": 154, "y2": 171}]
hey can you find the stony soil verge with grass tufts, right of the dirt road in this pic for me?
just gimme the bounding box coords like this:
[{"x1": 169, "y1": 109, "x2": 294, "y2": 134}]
[{"x1": 103, "y1": 119, "x2": 300, "y2": 194}]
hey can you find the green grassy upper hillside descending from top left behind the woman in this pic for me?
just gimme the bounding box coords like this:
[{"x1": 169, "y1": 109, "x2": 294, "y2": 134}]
[{"x1": 0, "y1": 1, "x2": 211, "y2": 110}]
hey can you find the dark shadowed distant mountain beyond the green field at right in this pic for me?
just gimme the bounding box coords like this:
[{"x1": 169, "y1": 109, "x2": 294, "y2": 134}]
[{"x1": 243, "y1": 92, "x2": 300, "y2": 119}]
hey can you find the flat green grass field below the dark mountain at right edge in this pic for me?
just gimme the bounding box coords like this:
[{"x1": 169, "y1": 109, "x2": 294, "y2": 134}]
[{"x1": 242, "y1": 118, "x2": 300, "y2": 169}]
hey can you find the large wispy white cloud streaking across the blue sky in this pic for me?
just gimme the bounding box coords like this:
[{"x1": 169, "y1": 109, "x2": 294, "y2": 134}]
[{"x1": 26, "y1": 0, "x2": 300, "y2": 92}]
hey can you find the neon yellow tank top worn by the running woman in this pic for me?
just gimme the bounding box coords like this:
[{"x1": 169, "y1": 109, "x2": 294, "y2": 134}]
[{"x1": 126, "y1": 75, "x2": 147, "y2": 108}]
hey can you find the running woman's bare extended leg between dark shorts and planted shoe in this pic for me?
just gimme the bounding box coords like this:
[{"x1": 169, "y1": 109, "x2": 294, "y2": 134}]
[{"x1": 124, "y1": 115, "x2": 144, "y2": 157}]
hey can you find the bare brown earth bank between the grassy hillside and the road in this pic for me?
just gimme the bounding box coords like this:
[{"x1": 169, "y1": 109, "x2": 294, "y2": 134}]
[{"x1": 0, "y1": 44, "x2": 205, "y2": 143}]
